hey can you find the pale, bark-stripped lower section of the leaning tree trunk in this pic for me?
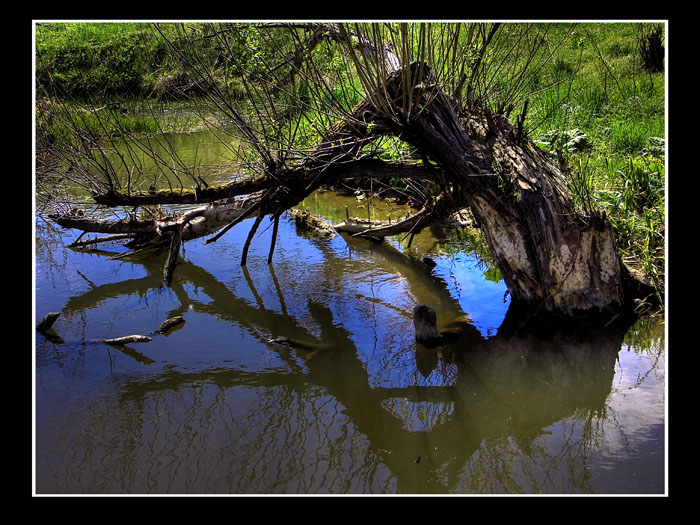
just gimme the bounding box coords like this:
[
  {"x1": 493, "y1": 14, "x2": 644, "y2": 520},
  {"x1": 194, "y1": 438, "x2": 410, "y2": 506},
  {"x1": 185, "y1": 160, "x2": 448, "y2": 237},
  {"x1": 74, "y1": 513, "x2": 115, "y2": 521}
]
[{"x1": 454, "y1": 111, "x2": 625, "y2": 314}]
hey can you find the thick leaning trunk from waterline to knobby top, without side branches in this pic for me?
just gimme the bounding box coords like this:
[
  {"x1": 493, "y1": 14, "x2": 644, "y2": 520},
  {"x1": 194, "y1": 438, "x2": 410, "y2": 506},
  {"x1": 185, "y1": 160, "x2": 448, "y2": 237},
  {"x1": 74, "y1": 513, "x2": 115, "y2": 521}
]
[{"x1": 320, "y1": 64, "x2": 644, "y2": 316}]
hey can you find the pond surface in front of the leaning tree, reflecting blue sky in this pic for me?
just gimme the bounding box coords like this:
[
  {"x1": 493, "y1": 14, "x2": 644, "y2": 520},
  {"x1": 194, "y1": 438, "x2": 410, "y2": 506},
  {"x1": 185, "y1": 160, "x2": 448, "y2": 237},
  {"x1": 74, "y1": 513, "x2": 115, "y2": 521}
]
[{"x1": 35, "y1": 132, "x2": 666, "y2": 495}]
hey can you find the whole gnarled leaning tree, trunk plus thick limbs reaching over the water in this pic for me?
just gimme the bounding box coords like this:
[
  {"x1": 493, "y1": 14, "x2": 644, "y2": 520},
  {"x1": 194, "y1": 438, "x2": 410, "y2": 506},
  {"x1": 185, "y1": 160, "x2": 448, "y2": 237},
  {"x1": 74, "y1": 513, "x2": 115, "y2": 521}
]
[{"x1": 49, "y1": 59, "x2": 656, "y2": 316}]
